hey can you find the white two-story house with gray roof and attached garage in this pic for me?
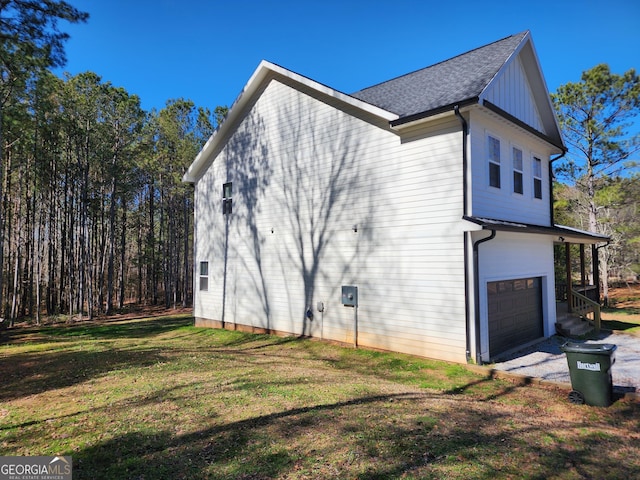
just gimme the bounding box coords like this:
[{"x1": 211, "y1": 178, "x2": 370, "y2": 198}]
[{"x1": 184, "y1": 32, "x2": 604, "y2": 363}]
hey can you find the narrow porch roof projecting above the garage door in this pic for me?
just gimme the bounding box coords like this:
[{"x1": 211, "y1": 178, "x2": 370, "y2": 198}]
[{"x1": 464, "y1": 216, "x2": 610, "y2": 245}]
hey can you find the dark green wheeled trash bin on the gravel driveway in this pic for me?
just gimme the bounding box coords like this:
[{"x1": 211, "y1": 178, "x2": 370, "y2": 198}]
[{"x1": 560, "y1": 342, "x2": 617, "y2": 407}]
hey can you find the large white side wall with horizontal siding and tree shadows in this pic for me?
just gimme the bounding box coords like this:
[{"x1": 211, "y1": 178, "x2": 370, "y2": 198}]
[{"x1": 194, "y1": 81, "x2": 466, "y2": 362}]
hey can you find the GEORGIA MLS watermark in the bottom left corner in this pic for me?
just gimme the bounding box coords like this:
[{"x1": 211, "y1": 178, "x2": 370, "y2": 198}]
[{"x1": 0, "y1": 457, "x2": 73, "y2": 480}]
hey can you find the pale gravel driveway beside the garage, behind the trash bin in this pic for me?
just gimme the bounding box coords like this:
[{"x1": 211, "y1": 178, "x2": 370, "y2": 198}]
[{"x1": 492, "y1": 331, "x2": 640, "y2": 393}]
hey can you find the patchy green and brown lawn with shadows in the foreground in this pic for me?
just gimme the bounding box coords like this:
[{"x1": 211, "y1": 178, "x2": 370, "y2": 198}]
[{"x1": 0, "y1": 306, "x2": 640, "y2": 479}]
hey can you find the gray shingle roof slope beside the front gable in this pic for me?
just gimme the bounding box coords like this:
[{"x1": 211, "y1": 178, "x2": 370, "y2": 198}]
[{"x1": 351, "y1": 32, "x2": 528, "y2": 119}]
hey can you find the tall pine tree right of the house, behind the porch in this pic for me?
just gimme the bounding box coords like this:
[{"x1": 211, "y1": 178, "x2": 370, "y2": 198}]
[{"x1": 551, "y1": 64, "x2": 640, "y2": 304}]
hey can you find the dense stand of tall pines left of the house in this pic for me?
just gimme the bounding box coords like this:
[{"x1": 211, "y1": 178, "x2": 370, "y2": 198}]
[{"x1": 0, "y1": 71, "x2": 224, "y2": 321}]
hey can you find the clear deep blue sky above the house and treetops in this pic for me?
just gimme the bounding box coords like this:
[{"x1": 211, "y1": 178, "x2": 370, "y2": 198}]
[{"x1": 61, "y1": 0, "x2": 640, "y2": 124}]
